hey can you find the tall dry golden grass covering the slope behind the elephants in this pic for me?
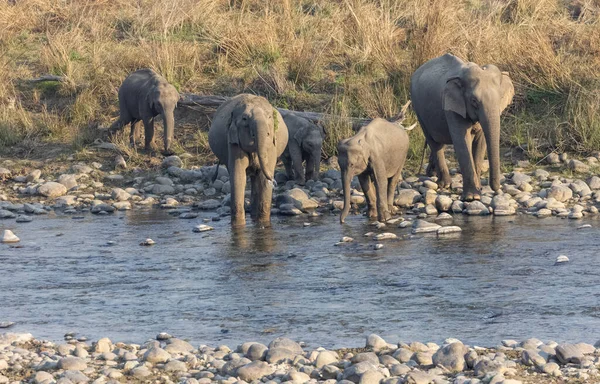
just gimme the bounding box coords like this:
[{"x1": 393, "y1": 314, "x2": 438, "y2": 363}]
[{"x1": 0, "y1": 0, "x2": 600, "y2": 157}]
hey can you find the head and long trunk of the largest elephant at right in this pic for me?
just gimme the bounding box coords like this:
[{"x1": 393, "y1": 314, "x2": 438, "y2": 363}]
[{"x1": 442, "y1": 63, "x2": 514, "y2": 191}]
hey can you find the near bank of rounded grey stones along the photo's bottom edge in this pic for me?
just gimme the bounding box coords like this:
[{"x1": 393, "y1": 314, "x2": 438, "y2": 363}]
[{"x1": 0, "y1": 333, "x2": 600, "y2": 384}]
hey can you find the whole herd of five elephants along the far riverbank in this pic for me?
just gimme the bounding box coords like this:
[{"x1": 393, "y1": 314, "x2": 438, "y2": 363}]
[{"x1": 111, "y1": 54, "x2": 514, "y2": 226}]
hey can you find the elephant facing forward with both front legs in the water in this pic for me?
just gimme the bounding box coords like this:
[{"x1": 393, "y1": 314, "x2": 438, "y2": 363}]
[{"x1": 208, "y1": 94, "x2": 288, "y2": 227}]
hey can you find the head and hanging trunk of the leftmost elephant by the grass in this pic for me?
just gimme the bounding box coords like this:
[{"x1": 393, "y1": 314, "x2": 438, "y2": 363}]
[{"x1": 146, "y1": 81, "x2": 179, "y2": 153}]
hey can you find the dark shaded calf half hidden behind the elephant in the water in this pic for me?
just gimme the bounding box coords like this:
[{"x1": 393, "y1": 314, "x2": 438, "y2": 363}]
[{"x1": 281, "y1": 112, "x2": 325, "y2": 185}]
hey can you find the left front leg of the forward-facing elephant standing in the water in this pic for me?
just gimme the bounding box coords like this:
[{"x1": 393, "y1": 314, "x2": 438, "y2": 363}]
[{"x1": 227, "y1": 149, "x2": 249, "y2": 227}]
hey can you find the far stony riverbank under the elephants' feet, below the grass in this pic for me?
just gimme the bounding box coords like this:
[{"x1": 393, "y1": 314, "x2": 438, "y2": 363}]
[{"x1": 0, "y1": 150, "x2": 600, "y2": 240}]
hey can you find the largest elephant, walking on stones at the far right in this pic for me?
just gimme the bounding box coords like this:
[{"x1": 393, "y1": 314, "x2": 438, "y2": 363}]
[{"x1": 410, "y1": 54, "x2": 514, "y2": 201}]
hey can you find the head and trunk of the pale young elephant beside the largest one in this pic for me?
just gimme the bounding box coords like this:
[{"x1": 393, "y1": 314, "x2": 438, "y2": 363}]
[{"x1": 338, "y1": 137, "x2": 369, "y2": 223}]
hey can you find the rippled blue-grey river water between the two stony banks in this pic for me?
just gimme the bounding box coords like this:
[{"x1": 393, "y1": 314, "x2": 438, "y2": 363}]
[{"x1": 0, "y1": 210, "x2": 600, "y2": 347}]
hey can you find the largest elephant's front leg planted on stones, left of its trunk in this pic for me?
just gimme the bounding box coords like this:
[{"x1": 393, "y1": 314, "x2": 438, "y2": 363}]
[{"x1": 450, "y1": 123, "x2": 481, "y2": 201}]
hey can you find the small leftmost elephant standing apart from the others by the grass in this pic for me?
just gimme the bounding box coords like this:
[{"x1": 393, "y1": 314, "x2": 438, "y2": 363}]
[{"x1": 110, "y1": 68, "x2": 179, "y2": 154}]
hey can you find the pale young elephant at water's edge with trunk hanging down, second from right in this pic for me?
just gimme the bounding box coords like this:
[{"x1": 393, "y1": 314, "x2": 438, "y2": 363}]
[{"x1": 337, "y1": 119, "x2": 409, "y2": 223}]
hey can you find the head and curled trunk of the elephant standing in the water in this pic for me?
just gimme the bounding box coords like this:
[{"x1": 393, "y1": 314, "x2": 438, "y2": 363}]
[{"x1": 227, "y1": 97, "x2": 283, "y2": 181}]
